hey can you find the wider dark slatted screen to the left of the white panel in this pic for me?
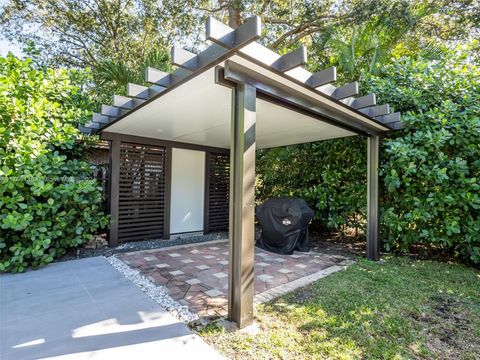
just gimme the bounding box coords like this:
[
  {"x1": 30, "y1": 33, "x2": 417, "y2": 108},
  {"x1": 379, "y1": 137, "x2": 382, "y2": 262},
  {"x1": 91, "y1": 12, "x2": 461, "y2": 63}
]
[{"x1": 118, "y1": 142, "x2": 166, "y2": 242}]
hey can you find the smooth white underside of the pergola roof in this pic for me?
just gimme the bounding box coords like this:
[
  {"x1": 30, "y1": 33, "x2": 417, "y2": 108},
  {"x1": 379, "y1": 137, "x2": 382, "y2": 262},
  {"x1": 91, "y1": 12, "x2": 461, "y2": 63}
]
[{"x1": 106, "y1": 64, "x2": 355, "y2": 149}]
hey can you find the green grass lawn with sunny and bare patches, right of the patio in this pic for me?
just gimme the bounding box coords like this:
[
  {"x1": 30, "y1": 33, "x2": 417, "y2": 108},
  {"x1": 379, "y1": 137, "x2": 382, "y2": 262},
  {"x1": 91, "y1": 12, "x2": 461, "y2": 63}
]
[{"x1": 200, "y1": 257, "x2": 480, "y2": 359}]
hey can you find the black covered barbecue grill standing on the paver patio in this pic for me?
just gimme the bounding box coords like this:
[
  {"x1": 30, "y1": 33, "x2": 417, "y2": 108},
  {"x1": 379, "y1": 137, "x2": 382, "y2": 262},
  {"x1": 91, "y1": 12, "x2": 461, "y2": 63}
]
[{"x1": 256, "y1": 198, "x2": 314, "y2": 254}]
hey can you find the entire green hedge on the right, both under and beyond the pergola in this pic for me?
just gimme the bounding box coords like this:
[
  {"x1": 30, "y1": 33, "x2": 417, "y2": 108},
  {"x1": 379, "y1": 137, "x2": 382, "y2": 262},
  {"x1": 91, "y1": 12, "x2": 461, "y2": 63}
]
[{"x1": 258, "y1": 44, "x2": 480, "y2": 263}]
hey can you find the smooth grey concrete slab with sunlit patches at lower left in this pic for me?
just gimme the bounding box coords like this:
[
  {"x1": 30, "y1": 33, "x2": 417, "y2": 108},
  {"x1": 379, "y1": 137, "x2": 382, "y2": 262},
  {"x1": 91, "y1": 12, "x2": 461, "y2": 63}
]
[{"x1": 0, "y1": 257, "x2": 221, "y2": 360}]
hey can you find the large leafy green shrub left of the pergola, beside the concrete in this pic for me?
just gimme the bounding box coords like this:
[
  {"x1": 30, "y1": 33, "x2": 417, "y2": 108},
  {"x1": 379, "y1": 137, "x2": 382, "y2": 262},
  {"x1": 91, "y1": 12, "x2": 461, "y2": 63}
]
[{"x1": 0, "y1": 55, "x2": 106, "y2": 272}]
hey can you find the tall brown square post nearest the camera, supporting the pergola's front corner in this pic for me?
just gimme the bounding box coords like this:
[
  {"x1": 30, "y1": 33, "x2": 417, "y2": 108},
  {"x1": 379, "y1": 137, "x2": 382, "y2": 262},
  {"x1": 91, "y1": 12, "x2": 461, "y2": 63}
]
[{"x1": 228, "y1": 84, "x2": 256, "y2": 328}]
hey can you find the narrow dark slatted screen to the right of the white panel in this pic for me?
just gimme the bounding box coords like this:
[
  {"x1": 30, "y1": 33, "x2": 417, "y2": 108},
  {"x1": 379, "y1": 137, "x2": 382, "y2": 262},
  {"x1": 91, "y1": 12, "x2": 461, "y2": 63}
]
[{"x1": 208, "y1": 153, "x2": 230, "y2": 231}]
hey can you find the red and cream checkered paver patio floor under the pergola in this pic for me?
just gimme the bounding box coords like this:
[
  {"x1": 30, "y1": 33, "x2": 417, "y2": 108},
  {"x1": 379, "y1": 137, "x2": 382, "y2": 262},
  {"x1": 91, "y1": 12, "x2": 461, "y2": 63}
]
[{"x1": 117, "y1": 241, "x2": 341, "y2": 316}]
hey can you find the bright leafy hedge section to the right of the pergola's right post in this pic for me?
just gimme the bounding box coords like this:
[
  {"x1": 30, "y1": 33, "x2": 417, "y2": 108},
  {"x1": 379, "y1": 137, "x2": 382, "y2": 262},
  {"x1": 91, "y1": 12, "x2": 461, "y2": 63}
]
[{"x1": 368, "y1": 48, "x2": 480, "y2": 263}]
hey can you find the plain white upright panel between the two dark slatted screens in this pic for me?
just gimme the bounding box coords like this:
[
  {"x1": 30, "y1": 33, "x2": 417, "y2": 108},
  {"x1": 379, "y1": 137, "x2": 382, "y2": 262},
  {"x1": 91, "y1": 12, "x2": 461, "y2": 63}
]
[{"x1": 170, "y1": 148, "x2": 205, "y2": 234}]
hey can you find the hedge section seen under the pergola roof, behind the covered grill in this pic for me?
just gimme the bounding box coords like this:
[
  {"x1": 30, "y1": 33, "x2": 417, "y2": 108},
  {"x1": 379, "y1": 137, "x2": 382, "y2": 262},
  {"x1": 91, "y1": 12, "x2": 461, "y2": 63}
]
[{"x1": 257, "y1": 136, "x2": 367, "y2": 229}]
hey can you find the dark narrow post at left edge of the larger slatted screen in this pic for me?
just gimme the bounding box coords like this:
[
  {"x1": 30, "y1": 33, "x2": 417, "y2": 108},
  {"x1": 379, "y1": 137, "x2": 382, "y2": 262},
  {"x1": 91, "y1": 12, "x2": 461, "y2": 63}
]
[{"x1": 108, "y1": 139, "x2": 120, "y2": 247}]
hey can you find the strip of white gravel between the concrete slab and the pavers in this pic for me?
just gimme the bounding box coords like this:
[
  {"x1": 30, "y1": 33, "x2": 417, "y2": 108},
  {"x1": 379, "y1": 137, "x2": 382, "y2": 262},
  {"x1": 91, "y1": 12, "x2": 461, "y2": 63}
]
[{"x1": 105, "y1": 256, "x2": 199, "y2": 323}]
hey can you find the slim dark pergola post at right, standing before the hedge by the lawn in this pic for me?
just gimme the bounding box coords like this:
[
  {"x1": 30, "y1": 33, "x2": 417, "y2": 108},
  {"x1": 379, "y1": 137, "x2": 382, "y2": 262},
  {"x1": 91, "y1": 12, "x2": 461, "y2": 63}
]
[{"x1": 367, "y1": 136, "x2": 380, "y2": 261}]
